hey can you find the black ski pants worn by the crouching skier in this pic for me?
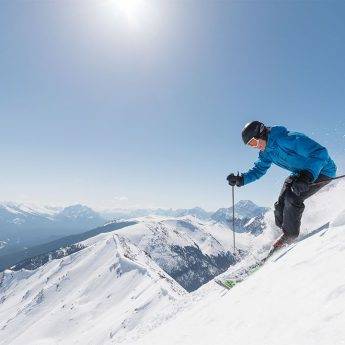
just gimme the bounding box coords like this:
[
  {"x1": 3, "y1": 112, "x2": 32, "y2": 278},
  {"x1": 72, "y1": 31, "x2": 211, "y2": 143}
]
[{"x1": 274, "y1": 175, "x2": 330, "y2": 237}]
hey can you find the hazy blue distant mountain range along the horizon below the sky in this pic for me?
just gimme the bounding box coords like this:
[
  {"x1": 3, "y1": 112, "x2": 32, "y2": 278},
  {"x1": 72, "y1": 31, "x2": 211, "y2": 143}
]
[{"x1": 0, "y1": 200, "x2": 267, "y2": 256}]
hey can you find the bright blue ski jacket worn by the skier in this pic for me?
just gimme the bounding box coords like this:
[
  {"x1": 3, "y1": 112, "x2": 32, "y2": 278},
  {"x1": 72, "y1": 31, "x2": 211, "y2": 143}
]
[{"x1": 243, "y1": 126, "x2": 337, "y2": 184}]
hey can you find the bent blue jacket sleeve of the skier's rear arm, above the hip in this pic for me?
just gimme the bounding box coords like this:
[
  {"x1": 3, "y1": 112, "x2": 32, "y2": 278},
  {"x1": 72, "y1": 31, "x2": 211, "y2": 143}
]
[{"x1": 296, "y1": 135, "x2": 329, "y2": 181}]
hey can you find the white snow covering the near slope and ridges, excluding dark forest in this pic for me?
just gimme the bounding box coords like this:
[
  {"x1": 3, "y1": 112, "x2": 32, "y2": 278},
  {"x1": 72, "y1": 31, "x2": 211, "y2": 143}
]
[{"x1": 0, "y1": 181, "x2": 345, "y2": 345}]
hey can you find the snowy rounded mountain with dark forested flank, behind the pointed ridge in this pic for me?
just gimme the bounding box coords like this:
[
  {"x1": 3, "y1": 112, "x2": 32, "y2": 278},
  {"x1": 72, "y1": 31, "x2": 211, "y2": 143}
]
[{"x1": 117, "y1": 216, "x2": 255, "y2": 291}]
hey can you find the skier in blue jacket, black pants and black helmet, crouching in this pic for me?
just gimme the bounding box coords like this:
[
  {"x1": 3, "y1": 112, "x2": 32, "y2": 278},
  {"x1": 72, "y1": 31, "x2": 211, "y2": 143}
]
[{"x1": 227, "y1": 121, "x2": 337, "y2": 248}]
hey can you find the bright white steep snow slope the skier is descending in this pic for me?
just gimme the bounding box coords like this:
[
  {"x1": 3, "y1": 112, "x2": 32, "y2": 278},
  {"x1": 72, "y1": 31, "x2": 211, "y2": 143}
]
[{"x1": 119, "y1": 181, "x2": 345, "y2": 345}]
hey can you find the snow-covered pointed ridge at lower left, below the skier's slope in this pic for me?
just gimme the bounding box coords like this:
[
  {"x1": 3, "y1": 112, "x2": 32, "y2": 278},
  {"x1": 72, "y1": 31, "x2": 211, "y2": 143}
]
[{"x1": 0, "y1": 233, "x2": 185, "y2": 345}]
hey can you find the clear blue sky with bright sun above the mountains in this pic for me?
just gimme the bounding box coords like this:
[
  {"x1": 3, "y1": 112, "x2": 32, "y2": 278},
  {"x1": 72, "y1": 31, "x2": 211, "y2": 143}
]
[{"x1": 0, "y1": 0, "x2": 345, "y2": 209}]
